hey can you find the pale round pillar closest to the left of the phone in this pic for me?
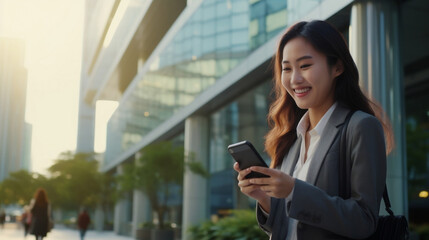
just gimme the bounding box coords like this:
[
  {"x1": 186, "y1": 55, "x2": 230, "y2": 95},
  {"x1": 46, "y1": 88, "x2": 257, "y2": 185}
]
[{"x1": 182, "y1": 116, "x2": 208, "y2": 239}]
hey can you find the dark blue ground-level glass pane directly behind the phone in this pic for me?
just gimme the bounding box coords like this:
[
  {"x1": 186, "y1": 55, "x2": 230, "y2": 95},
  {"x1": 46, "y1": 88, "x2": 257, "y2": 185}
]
[{"x1": 209, "y1": 80, "x2": 272, "y2": 215}]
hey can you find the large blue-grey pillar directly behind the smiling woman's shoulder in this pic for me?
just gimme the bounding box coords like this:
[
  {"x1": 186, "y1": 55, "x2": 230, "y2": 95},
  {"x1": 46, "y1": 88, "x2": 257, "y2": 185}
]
[{"x1": 349, "y1": 0, "x2": 408, "y2": 215}]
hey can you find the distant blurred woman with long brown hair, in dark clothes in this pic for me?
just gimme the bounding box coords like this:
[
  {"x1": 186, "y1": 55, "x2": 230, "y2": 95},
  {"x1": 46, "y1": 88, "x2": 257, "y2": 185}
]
[{"x1": 30, "y1": 188, "x2": 50, "y2": 240}]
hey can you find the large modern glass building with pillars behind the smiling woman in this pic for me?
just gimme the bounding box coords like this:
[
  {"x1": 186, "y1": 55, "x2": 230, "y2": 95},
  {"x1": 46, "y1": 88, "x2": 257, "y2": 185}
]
[{"x1": 77, "y1": 0, "x2": 429, "y2": 239}]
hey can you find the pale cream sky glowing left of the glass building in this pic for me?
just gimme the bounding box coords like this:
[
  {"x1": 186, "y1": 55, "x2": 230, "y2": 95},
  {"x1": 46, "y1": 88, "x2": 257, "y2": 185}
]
[{"x1": 0, "y1": 0, "x2": 84, "y2": 174}]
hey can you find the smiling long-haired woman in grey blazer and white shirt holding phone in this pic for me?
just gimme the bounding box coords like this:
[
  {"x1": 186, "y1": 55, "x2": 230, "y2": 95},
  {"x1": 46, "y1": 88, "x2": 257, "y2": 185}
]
[{"x1": 234, "y1": 21, "x2": 390, "y2": 240}]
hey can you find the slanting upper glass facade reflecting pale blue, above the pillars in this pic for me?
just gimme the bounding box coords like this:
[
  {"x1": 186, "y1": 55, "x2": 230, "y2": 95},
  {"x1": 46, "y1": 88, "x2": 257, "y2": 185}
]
[{"x1": 105, "y1": 0, "x2": 321, "y2": 163}]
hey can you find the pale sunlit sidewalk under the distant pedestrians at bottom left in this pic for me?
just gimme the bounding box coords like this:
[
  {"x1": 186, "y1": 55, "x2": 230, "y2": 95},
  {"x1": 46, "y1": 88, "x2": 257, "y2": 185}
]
[{"x1": 0, "y1": 223, "x2": 133, "y2": 240}]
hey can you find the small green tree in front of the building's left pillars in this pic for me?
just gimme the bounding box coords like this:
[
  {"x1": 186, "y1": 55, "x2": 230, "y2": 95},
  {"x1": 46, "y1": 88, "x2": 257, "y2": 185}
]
[{"x1": 118, "y1": 141, "x2": 208, "y2": 228}]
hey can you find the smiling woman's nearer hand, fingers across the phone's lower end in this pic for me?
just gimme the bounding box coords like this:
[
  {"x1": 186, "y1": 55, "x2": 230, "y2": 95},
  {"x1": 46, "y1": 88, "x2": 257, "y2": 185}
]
[{"x1": 244, "y1": 166, "x2": 295, "y2": 198}]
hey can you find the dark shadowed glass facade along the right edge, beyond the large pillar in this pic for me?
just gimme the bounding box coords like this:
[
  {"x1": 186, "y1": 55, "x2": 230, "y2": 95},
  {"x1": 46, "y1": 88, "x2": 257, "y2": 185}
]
[{"x1": 400, "y1": 0, "x2": 429, "y2": 227}]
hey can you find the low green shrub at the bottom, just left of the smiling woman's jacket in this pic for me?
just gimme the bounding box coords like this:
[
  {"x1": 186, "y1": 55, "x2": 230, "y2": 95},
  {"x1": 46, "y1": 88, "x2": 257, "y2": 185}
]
[{"x1": 188, "y1": 210, "x2": 268, "y2": 240}]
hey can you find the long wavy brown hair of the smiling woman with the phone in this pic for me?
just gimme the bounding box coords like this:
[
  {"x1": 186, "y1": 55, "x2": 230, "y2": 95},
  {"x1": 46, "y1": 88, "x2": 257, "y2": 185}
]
[{"x1": 265, "y1": 20, "x2": 393, "y2": 168}]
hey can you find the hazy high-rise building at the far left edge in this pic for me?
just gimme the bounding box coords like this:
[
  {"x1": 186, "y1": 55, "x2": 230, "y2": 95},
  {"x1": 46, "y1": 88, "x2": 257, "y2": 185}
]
[{"x1": 0, "y1": 38, "x2": 27, "y2": 181}]
